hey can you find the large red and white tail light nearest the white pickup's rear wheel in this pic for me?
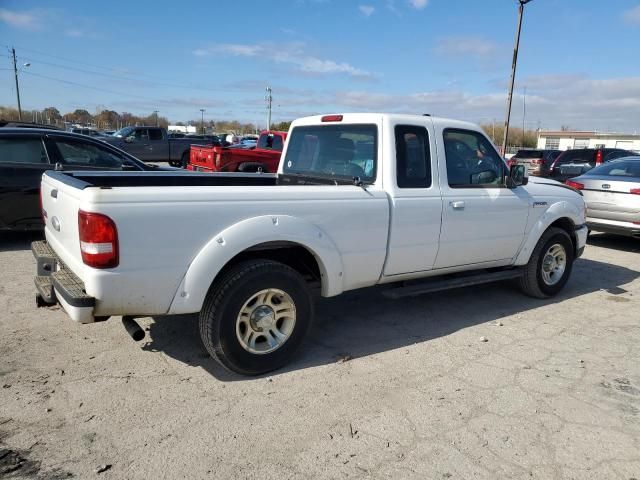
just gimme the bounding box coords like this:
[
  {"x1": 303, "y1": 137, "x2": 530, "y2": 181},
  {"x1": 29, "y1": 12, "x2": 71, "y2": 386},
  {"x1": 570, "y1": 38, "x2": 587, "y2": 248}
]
[{"x1": 78, "y1": 210, "x2": 120, "y2": 268}]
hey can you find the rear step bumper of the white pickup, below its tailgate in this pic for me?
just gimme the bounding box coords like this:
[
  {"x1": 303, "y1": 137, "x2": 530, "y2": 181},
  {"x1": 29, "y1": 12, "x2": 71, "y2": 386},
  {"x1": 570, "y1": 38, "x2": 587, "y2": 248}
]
[{"x1": 31, "y1": 240, "x2": 95, "y2": 323}]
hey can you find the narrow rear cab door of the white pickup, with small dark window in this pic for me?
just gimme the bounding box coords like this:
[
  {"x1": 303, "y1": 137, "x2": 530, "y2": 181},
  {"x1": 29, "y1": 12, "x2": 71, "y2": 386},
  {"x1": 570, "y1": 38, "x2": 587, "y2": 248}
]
[{"x1": 384, "y1": 124, "x2": 442, "y2": 276}]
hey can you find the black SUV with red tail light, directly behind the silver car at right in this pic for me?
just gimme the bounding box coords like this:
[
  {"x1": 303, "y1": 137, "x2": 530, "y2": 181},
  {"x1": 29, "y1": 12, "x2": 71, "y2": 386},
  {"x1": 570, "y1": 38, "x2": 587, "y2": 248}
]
[{"x1": 549, "y1": 148, "x2": 634, "y2": 182}]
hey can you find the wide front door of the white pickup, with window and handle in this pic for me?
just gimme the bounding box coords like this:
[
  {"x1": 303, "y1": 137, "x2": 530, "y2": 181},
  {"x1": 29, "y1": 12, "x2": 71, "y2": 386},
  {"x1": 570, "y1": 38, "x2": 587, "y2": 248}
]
[{"x1": 435, "y1": 128, "x2": 530, "y2": 268}]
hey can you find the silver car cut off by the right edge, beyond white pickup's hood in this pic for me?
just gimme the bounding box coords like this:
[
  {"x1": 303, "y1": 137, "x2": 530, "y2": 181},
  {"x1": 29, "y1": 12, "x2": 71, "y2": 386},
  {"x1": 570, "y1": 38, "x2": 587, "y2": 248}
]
[{"x1": 566, "y1": 156, "x2": 640, "y2": 238}]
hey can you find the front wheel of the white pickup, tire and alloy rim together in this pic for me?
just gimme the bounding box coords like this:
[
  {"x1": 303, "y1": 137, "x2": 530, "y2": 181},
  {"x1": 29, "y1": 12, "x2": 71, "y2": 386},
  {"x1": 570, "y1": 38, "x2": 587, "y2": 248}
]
[{"x1": 520, "y1": 227, "x2": 574, "y2": 298}]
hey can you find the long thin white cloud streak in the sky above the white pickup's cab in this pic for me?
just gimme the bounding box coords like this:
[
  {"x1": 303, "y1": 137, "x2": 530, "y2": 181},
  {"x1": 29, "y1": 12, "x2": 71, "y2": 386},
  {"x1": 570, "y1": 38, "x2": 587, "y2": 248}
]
[{"x1": 193, "y1": 43, "x2": 374, "y2": 79}]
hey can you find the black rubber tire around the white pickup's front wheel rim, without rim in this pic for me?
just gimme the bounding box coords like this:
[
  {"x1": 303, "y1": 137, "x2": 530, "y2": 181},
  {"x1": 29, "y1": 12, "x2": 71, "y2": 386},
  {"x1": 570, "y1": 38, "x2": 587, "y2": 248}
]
[{"x1": 519, "y1": 227, "x2": 574, "y2": 298}]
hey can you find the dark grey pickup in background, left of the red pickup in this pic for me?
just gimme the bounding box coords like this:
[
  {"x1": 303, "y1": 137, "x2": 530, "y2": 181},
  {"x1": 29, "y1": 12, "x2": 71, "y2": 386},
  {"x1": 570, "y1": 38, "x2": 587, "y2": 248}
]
[{"x1": 100, "y1": 127, "x2": 196, "y2": 168}]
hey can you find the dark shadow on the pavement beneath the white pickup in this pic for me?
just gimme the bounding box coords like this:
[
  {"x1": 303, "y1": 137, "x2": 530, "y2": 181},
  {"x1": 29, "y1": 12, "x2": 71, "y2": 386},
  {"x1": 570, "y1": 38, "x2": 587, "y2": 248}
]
[{"x1": 143, "y1": 255, "x2": 640, "y2": 381}]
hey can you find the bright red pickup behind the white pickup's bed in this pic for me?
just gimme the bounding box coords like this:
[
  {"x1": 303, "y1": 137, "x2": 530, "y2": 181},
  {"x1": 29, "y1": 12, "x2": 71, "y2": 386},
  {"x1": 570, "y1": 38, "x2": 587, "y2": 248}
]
[{"x1": 187, "y1": 131, "x2": 287, "y2": 173}]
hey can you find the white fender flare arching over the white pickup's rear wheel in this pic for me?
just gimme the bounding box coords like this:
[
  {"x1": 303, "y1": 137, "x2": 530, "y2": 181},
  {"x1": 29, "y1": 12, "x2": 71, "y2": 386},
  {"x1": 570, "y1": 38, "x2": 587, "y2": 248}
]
[{"x1": 168, "y1": 215, "x2": 343, "y2": 314}]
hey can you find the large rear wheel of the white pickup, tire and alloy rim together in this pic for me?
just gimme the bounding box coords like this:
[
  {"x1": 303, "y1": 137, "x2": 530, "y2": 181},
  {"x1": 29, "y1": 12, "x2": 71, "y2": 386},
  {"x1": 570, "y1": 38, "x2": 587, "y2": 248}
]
[{"x1": 200, "y1": 260, "x2": 313, "y2": 375}]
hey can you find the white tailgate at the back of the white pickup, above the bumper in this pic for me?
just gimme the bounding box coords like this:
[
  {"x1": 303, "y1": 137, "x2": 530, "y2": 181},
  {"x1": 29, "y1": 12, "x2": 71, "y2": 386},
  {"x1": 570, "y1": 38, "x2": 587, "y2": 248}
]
[{"x1": 41, "y1": 173, "x2": 84, "y2": 278}]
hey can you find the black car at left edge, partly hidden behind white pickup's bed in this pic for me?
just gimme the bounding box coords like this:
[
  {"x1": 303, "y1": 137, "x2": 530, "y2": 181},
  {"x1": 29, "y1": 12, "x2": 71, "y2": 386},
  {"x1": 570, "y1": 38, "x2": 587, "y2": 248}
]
[{"x1": 0, "y1": 127, "x2": 165, "y2": 231}]
